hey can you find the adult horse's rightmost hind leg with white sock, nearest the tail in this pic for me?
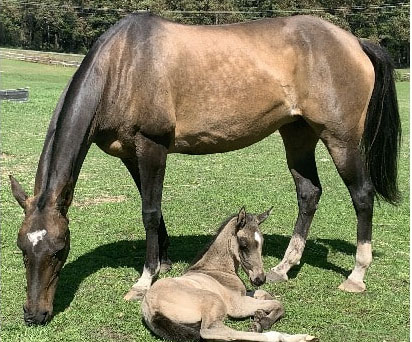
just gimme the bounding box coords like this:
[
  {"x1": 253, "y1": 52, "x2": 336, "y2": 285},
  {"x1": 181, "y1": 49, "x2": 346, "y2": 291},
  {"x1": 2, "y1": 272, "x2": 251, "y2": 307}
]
[{"x1": 325, "y1": 137, "x2": 374, "y2": 292}]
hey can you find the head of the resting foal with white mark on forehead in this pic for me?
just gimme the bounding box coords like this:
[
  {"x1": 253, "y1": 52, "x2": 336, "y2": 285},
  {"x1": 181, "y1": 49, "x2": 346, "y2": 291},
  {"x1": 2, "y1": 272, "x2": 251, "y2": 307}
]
[{"x1": 236, "y1": 208, "x2": 272, "y2": 286}]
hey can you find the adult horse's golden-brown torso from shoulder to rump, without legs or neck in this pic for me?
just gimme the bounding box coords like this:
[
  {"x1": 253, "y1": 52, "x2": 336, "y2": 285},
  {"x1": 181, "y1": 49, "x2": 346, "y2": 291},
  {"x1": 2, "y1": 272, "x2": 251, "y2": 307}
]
[{"x1": 90, "y1": 15, "x2": 373, "y2": 154}]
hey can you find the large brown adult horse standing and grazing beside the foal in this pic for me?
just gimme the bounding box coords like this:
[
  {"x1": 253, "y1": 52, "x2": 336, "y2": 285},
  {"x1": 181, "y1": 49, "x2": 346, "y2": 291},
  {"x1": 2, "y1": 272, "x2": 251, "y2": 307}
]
[{"x1": 11, "y1": 14, "x2": 400, "y2": 324}]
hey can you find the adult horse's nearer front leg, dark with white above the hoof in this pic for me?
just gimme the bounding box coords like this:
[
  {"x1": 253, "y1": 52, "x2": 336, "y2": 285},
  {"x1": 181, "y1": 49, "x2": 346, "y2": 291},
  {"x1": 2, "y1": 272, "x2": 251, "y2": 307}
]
[{"x1": 125, "y1": 134, "x2": 167, "y2": 300}]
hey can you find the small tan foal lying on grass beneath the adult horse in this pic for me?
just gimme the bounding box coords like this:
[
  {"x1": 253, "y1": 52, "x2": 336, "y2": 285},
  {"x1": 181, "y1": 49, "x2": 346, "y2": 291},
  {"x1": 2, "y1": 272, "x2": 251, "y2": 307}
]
[{"x1": 142, "y1": 208, "x2": 316, "y2": 342}]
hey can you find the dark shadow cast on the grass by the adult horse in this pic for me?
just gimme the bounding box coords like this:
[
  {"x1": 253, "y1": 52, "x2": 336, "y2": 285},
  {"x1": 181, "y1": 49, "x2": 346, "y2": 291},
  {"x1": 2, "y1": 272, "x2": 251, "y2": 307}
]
[{"x1": 54, "y1": 234, "x2": 366, "y2": 314}]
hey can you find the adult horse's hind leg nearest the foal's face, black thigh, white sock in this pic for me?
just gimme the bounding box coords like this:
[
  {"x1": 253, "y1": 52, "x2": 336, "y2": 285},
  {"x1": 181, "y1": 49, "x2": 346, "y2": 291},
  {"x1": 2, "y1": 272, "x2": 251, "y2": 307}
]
[{"x1": 266, "y1": 120, "x2": 322, "y2": 282}]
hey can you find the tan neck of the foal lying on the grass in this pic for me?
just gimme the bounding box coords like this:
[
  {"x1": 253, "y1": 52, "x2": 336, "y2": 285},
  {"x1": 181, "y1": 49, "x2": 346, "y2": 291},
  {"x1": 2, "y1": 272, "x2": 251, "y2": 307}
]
[{"x1": 189, "y1": 220, "x2": 239, "y2": 274}]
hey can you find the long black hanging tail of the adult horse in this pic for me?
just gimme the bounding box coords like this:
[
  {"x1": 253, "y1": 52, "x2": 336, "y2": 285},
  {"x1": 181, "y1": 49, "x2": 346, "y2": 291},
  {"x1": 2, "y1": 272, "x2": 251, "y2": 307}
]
[{"x1": 360, "y1": 41, "x2": 401, "y2": 204}]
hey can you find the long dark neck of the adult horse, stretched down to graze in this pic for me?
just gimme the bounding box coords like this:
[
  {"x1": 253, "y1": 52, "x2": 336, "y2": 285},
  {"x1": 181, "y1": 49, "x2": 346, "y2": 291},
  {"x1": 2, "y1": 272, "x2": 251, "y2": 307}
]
[{"x1": 34, "y1": 46, "x2": 105, "y2": 210}]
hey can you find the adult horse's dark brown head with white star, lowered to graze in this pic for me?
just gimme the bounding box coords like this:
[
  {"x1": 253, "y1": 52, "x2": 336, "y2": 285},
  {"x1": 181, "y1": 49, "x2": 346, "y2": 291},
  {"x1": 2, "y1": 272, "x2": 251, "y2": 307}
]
[{"x1": 10, "y1": 177, "x2": 70, "y2": 325}]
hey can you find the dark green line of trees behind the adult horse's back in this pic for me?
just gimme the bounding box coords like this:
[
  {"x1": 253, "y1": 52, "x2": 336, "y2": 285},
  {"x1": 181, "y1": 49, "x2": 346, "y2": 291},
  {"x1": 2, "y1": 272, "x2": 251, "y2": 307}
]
[{"x1": 0, "y1": 0, "x2": 410, "y2": 67}]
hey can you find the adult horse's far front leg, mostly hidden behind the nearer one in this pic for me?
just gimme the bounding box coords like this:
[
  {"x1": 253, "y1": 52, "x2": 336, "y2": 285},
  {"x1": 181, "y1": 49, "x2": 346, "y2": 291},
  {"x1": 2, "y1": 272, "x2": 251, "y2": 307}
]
[{"x1": 122, "y1": 158, "x2": 172, "y2": 272}]
